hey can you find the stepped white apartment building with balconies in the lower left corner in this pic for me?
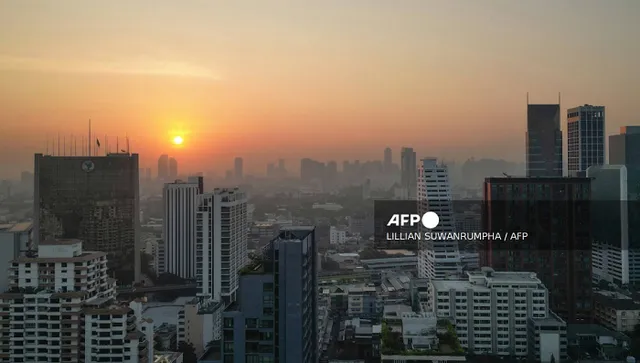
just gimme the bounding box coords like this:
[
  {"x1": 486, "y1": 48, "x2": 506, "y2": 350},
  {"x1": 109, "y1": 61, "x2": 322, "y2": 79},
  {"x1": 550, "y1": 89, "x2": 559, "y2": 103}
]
[{"x1": 0, "y1": 240, "x2": 148, "y2": 363}]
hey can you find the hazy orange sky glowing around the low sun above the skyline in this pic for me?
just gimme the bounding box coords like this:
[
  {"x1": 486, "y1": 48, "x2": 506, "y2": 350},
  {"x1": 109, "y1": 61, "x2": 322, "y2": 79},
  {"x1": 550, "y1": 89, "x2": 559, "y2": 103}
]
[{"x1": 0, "y1": 0, "x2": 640, "y2": 174}]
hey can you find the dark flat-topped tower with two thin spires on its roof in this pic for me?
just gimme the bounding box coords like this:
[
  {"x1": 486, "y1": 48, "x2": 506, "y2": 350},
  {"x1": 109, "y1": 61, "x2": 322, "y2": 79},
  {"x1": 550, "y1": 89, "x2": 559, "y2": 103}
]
[{"x1": 526, "y1": 104, "x2": 562, "y2": 177}]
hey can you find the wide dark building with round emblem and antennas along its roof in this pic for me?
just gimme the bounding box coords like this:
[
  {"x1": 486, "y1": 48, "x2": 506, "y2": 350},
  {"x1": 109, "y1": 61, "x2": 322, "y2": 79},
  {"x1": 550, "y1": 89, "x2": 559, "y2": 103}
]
[{"x1": 33, "y1": 153, "x2": 140, "y2": 284}]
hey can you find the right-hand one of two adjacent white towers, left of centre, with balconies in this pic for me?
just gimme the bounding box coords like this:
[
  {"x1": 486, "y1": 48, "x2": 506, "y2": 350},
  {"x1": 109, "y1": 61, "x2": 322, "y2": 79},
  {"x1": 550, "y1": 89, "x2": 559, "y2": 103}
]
[{"x1": 196, "y1": 188, "x2": 248, "y2": 305}]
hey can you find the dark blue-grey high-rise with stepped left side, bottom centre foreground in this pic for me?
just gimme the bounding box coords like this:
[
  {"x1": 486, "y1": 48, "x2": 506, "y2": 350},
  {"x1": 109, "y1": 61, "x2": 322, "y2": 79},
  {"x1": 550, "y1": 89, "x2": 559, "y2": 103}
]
[{"x1": 222, "y1": 226, "x2": 318, "y2": 363}]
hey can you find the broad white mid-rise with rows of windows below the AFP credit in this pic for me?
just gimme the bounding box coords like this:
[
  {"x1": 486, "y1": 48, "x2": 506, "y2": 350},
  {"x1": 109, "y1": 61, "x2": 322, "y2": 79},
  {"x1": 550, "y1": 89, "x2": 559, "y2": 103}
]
[{"x1": 427, "y1": 267, "x2": 567, "y2": 362}]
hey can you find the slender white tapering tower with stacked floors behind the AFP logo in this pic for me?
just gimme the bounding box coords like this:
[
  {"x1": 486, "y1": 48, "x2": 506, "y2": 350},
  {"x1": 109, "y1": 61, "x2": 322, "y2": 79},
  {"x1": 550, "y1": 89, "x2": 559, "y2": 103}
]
[{"x1": 418, "y1": 158, "x2": 462, "y2": 279}]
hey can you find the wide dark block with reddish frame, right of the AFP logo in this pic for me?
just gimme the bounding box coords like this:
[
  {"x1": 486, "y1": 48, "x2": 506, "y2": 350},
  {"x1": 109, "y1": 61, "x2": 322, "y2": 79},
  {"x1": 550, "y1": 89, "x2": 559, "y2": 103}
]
[{"x1": 481, "y1": 177, "x2": 592, "y2": 323}]
